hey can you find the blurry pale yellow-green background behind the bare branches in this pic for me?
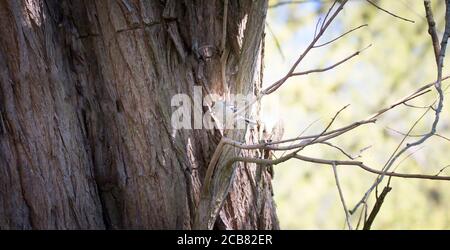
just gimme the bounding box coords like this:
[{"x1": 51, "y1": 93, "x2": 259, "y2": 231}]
[{"x1": 263, "y1": 0, "x2": 450, "y2": 229}]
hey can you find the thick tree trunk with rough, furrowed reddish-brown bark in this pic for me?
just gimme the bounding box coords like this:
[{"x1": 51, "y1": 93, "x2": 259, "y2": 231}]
[{"x1": 0, "y1": 0, "x2": 278, "y2": 229}]
